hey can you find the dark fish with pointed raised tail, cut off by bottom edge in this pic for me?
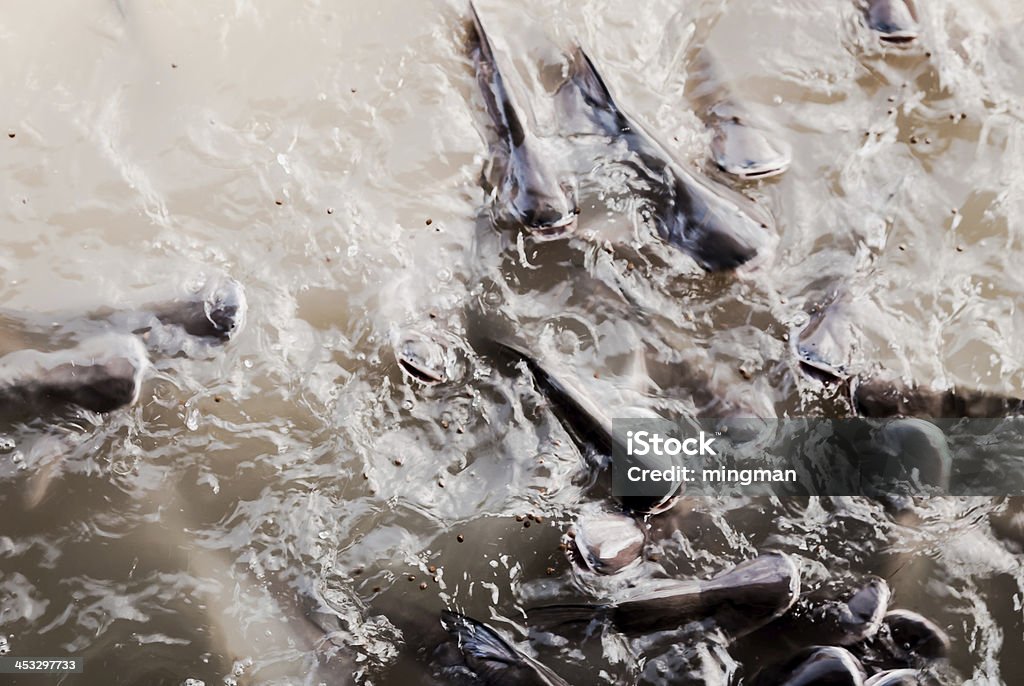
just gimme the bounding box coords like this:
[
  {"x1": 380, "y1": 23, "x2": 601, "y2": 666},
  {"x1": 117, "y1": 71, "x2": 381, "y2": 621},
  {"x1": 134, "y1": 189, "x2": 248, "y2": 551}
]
[{"x1": 433, "y1": 610, "x2": 568, "y2": 686}]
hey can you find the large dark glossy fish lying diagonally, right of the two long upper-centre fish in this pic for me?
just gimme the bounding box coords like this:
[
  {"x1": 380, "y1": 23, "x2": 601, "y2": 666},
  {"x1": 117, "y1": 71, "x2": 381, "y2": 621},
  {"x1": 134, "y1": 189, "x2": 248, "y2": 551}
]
[{"x1": 559, "y1": 47, "x2": 776, "y2": 271}]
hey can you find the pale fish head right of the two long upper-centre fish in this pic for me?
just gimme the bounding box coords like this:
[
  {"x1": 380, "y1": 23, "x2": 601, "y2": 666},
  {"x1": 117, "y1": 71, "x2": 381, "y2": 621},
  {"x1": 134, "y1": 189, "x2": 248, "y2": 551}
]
[{"x1": 711, "y1": 115, "x2": 793, "y2": 180}]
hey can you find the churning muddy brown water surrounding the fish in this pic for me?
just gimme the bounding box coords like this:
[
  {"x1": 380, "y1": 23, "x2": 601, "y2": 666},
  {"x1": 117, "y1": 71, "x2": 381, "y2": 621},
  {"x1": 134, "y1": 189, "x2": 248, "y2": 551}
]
[{"x1": 0, "y1": 0, "x2": 1024, "y2": 684}]
